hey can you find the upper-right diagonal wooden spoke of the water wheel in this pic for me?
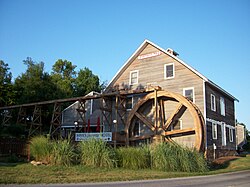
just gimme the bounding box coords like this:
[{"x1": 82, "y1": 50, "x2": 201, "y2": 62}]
[{"x1": 163, "y1": 103, "x2": 187, "y2": 130}]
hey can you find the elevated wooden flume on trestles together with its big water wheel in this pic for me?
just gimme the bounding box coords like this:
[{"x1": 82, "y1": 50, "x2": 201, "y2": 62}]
[{"x1": 0, "y1": 87, "x2": 205, "y2": 151}]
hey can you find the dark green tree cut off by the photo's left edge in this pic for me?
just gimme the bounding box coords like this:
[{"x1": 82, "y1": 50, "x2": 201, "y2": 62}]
[{"x1": 0, "y1": 60, "x2": 15, "y2": 106}]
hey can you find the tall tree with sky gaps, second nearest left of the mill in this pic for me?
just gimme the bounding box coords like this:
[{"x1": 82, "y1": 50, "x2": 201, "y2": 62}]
[{"x1": 51, "y1": 59, "x2": 76, "y2": 98}]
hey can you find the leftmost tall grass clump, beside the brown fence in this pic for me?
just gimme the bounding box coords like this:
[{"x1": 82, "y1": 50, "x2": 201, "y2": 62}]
[{"x1": 30, "y1": 136, "x2": 52, "y2": 163}]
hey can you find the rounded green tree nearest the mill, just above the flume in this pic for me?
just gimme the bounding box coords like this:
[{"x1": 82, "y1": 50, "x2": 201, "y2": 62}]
[{"x1": 75, "y1": 67, "x2": 104, "y2": 96}]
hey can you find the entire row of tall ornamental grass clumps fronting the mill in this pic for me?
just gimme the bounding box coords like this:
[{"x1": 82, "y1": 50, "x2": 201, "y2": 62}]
[{"x1": 30, "y1": 136, "x2": 208, "y2": 172}]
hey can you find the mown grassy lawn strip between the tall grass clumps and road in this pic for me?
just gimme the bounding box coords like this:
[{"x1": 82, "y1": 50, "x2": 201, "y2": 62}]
[{"x1": 0, "y1": 156, "x2": 250, "y2": 184}]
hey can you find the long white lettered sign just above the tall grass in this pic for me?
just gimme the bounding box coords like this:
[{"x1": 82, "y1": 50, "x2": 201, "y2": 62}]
[{"x1": 75, "y1": 132, "x2": 112, "y2": 142}]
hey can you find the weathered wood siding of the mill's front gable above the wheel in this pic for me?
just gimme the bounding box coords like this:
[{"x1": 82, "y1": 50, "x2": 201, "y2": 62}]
[{"x1": 107, "y1": 44, "x2": 204, "y2": 113}]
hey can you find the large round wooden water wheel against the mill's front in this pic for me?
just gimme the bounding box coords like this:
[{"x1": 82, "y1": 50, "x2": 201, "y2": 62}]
[{"x1": 125, "y1": 90, "x2": 205, "y2": 151}]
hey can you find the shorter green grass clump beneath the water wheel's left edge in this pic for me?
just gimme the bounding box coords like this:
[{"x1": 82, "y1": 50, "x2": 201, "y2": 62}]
[{"x1": 117, "y1": 146, "x2": 150, "y2": 169}]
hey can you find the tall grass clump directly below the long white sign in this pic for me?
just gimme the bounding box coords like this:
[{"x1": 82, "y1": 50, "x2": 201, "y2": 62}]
[{"x1": 79, "y1": 139, "x2": 117, "y2": 168}]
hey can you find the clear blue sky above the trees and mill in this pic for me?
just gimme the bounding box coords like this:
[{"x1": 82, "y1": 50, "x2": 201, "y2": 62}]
[{"x1": 0, "y1": 0, "x2": 250, "y2": 129}]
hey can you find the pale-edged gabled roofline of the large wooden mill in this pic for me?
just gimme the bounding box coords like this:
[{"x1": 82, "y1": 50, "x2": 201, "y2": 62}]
[{"x1": 108, "y1": 40, "x2": 239, "y2": 102}]
